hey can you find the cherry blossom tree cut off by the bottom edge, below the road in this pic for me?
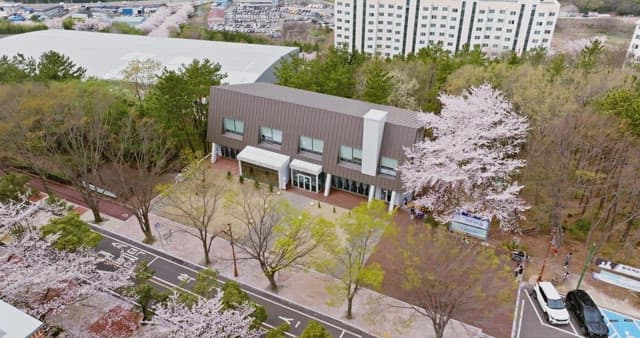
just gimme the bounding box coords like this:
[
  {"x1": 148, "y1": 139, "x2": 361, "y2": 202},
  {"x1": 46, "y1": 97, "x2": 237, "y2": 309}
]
[{"x1": 150, "y1": 292, "x2": 263, "y2": 338}]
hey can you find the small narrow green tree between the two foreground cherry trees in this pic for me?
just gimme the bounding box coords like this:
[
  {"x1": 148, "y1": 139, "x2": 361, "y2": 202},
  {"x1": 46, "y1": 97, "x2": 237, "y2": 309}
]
[{"x1": 125, "y1": 260, "x2": 169, "y2": 321}]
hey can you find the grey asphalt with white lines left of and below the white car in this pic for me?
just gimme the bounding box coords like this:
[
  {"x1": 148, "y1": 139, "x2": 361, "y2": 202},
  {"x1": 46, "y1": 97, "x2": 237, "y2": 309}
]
[{"x1": 513, "y1": 286, "x2": 582, "y2": 338}]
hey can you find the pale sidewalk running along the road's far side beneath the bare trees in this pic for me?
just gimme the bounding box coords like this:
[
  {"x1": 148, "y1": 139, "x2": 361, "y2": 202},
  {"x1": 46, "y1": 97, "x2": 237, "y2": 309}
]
[{"x1": 81, "y1": 213, "x2": 484, "y2": 338}]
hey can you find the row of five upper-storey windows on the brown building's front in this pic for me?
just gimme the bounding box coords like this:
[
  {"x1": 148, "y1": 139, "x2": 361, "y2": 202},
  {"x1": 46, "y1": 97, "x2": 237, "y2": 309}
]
[{"x1": 223, "y1": 118, "x2": 398, "y2": 176}]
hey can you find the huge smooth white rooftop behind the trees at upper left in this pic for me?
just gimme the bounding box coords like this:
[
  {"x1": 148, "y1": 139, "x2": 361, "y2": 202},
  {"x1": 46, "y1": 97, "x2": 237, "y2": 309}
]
[{"x1": 0, "y1": 30, "x2": 298, "y2": 84}]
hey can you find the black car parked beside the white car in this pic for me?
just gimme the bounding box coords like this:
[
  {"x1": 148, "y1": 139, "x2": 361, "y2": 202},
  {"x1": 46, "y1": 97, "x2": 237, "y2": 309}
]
[{"x1": 565, "y1": 289, "x2": 609, "y2": 338}]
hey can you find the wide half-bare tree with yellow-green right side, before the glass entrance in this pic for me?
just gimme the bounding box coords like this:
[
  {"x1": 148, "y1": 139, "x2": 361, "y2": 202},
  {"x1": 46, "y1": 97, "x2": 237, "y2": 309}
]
[{"x1": 227, "y1": 188, "x2": 334, "y2": 291}]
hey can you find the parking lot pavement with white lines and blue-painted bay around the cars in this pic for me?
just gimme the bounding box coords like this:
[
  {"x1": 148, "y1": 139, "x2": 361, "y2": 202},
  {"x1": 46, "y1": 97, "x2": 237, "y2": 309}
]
[{"x1": 513, "y1": 285, "x2": 640, "y2": 338}]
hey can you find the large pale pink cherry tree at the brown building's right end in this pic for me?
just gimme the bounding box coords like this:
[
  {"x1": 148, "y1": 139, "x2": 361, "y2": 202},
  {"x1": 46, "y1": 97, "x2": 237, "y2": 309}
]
[{"x1": 400, "y1": 84, "x2": 529, "y2": 230}]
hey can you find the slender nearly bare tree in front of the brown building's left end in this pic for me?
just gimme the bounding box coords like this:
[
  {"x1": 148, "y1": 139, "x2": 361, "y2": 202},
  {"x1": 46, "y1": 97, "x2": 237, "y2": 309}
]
[{"x1": 163, "y1": 161, "x2": 227, "y2": 266}]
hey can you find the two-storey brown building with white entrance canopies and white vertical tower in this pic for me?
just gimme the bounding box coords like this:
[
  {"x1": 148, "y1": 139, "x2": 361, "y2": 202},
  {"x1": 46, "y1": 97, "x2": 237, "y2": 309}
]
[{"x1": 208, "y1": 83, "x2": 423, "y2": 210}]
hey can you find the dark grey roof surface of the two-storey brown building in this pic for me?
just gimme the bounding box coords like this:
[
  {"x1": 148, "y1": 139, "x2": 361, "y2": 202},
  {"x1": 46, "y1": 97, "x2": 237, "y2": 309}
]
[{"x1": 217, "y1": 82, "x2": 420, "y2": 128}]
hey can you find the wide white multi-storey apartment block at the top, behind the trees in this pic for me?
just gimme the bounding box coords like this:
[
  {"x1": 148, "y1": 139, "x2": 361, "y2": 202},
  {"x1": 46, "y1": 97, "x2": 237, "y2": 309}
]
[{"x1": 334, "y1": 0, "x2": 560, "y2": 57}]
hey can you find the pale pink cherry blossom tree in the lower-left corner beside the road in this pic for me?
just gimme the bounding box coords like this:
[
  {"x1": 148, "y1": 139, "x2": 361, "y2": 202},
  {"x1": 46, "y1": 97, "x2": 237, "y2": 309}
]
[{"x1": 0, "y1": 231, "x2": 131, "y2": 320}]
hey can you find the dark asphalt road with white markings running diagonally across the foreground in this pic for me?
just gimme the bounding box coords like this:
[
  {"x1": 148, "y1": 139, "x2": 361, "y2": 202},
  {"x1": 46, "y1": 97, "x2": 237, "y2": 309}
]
[{"x1": 91, "y1": 225, "x2": 373, "y2": 338}]
